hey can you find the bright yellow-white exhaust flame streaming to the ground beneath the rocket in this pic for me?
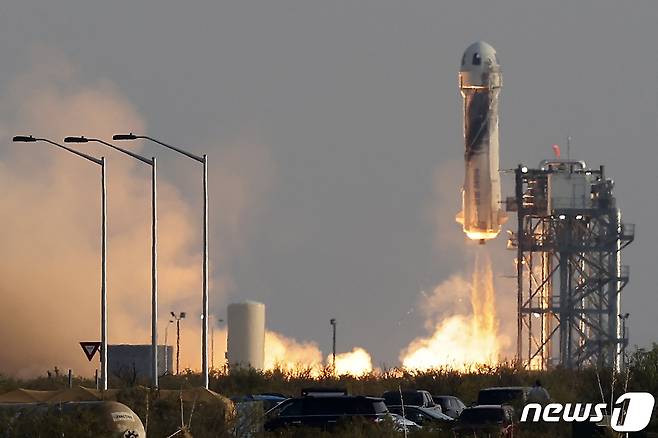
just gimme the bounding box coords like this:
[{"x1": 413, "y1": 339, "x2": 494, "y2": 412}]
[{"x1": 400, "y1": 251, "x2": 504, "y2": 371}]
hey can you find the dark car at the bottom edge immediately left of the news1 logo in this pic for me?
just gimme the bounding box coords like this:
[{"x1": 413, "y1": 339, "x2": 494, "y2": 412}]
[{"x1": 453, "y1": 405, "x2": 518, "y2": 438}]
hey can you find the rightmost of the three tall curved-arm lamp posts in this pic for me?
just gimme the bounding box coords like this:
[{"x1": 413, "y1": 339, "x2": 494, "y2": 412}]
[{"x1": 112, "y1": 133, "x2": 209, "y2": 389}]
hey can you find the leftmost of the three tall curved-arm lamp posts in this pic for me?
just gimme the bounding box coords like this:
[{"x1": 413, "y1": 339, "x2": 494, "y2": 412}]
[{"x1": 13, "y1": 135, "x2": 107, "y2": 391}]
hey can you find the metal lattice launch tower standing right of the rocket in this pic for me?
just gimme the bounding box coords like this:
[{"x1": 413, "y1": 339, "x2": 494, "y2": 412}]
[{"x1": 507, "y1": 160, "x2": 635, "y2": 369}]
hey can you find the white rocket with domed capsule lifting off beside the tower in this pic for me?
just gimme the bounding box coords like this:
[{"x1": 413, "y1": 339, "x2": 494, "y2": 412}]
[{"x1": 456, "y1": 41, "x2": 507, "y2": 244}]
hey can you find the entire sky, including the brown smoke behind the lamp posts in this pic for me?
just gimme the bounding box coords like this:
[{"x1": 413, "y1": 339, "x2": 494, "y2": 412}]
[{"x1": 0, "y1": 0, "x2": 658, "y2": 374}]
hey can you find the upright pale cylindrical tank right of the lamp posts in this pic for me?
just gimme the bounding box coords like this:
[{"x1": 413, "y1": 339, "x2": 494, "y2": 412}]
[{"x1": 227, "y1": 301, "x2": 265, "y2": 369}]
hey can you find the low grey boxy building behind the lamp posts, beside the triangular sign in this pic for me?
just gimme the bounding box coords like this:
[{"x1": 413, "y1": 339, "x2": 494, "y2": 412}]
[{"x1": 107, "y1": 344, "x2": 174, "y2": 380}]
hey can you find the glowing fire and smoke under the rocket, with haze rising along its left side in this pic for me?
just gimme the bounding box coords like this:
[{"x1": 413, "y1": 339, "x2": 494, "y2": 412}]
[{"x1": 399, "y1": 157, "x2": 516, "y2": 369}]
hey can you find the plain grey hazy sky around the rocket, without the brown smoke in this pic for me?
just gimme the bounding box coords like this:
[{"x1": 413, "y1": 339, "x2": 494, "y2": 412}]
[{"x1": 0, "y1": 0, "x2": 658, "y2": 370}]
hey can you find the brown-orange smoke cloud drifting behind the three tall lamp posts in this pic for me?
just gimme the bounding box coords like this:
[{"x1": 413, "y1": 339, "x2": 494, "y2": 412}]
[{"x1": 0, "y1": 49, "x2": 271, "y2": 377}]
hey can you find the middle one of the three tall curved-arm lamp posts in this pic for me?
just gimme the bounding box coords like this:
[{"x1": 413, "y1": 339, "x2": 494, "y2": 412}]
[{"x1": 64, "y1": 136, "x2": 160, "y2": 389}]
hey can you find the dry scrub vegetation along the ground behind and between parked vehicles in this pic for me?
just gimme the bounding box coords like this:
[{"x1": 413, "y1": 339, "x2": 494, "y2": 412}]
[{"x1": 0, "y1": 345, "x2": 658, "y2": 438}]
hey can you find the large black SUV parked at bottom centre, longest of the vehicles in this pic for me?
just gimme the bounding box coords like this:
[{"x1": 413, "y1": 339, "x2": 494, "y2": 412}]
[{"x1": 265, "y1": 395, "x2": 388, "y2": 431}]
